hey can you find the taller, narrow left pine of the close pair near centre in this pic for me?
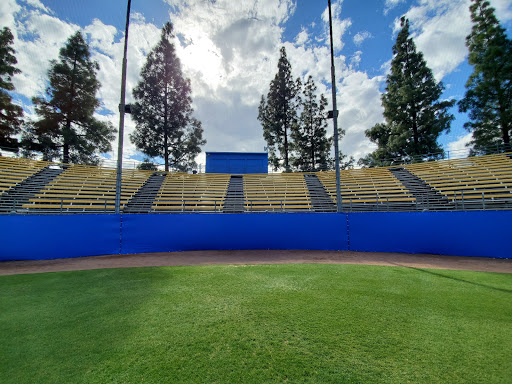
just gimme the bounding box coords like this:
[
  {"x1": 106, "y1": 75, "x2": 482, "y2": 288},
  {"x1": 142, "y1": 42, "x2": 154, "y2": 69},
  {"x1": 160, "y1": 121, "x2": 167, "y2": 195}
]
[{"x1": 258, "y1": 47, "x2": 301, "y2": 171}]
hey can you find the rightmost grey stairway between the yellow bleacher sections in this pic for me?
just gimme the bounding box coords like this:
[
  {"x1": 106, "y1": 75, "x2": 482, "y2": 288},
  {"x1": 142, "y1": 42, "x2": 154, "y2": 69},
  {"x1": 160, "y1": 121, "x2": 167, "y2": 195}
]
[{"x1": 389, "y1": 167, "x2": 455, "y2": 211}]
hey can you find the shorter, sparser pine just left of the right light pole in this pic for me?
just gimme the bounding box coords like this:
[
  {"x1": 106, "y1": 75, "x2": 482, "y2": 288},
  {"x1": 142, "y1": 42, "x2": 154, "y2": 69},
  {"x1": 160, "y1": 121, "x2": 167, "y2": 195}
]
[{"x1": 291, "y1": 76, "x2": 332, "y2": 171}]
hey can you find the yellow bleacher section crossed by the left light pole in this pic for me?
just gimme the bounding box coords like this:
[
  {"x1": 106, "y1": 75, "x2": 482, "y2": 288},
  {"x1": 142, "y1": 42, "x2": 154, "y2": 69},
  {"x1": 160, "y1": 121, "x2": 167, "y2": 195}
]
[{"x1": 23, "y1": 164, "x2": 153, "y2": 212}]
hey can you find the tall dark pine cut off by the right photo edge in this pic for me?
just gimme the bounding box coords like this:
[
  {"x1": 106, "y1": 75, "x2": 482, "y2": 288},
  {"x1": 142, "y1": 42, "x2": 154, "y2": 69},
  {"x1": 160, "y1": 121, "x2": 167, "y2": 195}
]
[{"x1": 459, "y1": 0, "x2": 512, "y2": 154}]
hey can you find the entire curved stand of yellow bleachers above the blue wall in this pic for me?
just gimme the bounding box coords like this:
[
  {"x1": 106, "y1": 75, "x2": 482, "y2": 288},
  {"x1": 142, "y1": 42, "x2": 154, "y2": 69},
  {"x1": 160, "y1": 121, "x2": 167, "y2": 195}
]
[{"x1": 0, "y1": 154, "x2": 512, "y2": 213}]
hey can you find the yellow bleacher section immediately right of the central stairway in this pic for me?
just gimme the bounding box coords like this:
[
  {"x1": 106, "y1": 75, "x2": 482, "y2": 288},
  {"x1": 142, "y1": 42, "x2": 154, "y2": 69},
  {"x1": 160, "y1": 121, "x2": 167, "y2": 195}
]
[{"x1": 243, "y1": 173, "x2": 312, "y2": 212}]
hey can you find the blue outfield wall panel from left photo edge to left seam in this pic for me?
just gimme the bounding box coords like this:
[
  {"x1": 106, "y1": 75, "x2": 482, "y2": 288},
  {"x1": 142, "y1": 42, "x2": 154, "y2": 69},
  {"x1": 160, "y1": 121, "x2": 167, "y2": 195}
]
[{"x1": 0, "y1": 215, "x2": 121, "y2": 260}]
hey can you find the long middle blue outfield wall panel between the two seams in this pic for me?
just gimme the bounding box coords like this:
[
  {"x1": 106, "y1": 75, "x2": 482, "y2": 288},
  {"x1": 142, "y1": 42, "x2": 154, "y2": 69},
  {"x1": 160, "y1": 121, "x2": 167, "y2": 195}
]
[{"x1": 121, "y1": 213, "x2": 348, "y2": 254}]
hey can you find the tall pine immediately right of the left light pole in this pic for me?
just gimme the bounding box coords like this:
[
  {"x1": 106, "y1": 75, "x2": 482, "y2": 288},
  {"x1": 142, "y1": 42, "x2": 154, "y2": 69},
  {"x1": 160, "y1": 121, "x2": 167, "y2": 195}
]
[{"x1": 130, "y1": 23, "x2": 206, "y2": 171}]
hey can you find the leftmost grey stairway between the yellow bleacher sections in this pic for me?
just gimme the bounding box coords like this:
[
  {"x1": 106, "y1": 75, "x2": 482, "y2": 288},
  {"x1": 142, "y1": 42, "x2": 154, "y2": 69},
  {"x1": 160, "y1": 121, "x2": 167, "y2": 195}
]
[{"x1": 0, "y1": 166, "x2": 64, "y2": 213}]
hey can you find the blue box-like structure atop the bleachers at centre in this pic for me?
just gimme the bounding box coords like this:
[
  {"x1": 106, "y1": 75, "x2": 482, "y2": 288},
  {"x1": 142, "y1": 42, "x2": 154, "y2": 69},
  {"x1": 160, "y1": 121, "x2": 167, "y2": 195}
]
[{"x1": 206, "y1": 152, "x2": 268, "y2": 174}]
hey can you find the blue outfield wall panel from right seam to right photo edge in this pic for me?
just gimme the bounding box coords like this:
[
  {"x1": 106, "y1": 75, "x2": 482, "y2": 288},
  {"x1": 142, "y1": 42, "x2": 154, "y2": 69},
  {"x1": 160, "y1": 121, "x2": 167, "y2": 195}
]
[{"x1": 348, "y1": 211, "x2": 512, "y2": 258}]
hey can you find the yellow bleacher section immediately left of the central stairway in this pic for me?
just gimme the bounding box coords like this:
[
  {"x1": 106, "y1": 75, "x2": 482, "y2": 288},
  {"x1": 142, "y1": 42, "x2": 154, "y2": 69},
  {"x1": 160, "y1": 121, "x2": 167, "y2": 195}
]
[{"x1": 152, "y1": 173, "x2": 231, "y2": 212}]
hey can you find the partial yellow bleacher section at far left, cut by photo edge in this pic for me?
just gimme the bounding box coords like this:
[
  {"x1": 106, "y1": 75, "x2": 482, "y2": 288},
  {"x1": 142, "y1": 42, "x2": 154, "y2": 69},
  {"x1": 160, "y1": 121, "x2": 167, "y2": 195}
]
[{"x1": 0, "y1": 156, "x2": 50, "y2": 194}]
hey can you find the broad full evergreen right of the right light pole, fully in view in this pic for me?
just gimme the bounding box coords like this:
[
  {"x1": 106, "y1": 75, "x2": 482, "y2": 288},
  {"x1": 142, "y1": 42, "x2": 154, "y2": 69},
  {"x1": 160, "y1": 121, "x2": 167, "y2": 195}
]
[{"x1": 363, "y1": 18, "x2": 455, "y2": 163}]
